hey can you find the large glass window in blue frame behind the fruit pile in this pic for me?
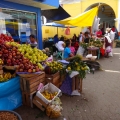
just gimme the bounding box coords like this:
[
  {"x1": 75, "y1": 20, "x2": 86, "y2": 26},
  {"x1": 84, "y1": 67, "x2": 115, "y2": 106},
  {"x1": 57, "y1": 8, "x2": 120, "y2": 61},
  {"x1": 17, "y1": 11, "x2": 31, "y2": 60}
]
[{"x1": 0, "y1": 8, "x2": 37, "y2": 42}]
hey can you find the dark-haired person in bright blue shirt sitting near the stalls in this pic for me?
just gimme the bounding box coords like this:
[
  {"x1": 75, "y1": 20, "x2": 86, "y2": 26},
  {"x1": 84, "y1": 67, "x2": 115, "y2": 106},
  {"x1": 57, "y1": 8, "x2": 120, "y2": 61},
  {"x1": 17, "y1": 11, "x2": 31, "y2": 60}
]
[{"x1": 64, "y1": 40, "x2": 74, "y2": 59}]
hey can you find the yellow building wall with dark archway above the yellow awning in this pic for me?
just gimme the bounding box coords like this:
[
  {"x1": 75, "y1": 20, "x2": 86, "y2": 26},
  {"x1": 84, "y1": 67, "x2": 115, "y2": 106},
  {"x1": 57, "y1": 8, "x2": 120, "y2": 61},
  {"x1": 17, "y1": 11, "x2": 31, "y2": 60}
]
[{"x1": 63, "y1": 0, "x2": 120, "y2": 32}]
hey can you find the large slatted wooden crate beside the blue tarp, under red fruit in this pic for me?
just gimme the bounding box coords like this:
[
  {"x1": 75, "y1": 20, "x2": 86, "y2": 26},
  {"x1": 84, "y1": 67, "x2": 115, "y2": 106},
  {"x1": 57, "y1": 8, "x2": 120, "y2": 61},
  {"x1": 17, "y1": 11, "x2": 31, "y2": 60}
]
[{"x1": 20, "y1": 73, "x2": 45, "y2": 94}]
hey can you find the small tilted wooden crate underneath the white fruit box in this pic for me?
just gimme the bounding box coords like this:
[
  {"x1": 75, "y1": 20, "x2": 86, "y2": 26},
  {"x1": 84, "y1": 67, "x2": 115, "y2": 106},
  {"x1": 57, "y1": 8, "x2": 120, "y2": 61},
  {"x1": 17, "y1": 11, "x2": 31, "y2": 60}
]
[{"x1": 33, "y1": 96, "x2": 48, "y2": 111}]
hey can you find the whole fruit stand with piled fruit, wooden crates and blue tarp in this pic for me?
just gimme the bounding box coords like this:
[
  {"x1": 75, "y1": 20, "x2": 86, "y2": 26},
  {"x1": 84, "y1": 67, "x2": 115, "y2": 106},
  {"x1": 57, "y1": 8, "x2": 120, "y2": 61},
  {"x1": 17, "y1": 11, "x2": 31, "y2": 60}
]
[{"x1": 0, "y1": 34, "x2": 88, "y2": 118}]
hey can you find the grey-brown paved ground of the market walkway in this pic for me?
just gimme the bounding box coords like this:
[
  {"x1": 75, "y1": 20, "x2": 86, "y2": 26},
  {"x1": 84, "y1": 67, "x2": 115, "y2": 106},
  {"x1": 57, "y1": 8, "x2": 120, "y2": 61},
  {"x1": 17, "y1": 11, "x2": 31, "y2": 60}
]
[{"x1": 16, "y1": 48, "x2": 120, "y2": 120}]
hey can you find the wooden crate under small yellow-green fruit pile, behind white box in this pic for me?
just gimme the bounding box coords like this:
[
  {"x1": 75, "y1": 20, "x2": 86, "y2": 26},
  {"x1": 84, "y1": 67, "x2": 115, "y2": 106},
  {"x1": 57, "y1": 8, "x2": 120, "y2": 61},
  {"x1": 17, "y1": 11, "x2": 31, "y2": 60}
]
[{"x1": 45, "y1": 72, "x2": 60, "y2": 86}]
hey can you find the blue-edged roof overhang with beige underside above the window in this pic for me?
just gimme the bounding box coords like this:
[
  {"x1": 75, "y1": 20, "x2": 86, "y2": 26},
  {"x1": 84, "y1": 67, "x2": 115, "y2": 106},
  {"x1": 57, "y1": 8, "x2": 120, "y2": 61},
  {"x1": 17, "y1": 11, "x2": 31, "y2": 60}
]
[{"x1": 4, "y1": 0, "x2": 59, "y2": 10}]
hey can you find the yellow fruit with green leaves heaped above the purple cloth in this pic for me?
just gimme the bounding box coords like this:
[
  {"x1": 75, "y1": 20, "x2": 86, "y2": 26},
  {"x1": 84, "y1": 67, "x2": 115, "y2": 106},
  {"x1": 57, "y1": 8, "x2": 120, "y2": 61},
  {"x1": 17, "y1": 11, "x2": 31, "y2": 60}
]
[{"x1": 67, "y1": 55, "x2": 89, "y2": 78}]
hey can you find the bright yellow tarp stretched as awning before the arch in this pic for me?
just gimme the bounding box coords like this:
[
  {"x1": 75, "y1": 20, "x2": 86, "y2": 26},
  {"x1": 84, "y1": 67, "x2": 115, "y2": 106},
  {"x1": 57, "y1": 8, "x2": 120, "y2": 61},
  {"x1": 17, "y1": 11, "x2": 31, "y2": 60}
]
[{"x1": 55, "y1": 7, "x2": 98, "y2": 27}]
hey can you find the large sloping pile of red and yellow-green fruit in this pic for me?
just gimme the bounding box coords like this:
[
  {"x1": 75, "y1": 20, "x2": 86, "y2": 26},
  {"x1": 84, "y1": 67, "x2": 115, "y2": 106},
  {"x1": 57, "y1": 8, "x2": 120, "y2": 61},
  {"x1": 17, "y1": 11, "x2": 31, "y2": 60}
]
[{"x1": 0, "y1": 34, "x2": 48, "y2": 73}]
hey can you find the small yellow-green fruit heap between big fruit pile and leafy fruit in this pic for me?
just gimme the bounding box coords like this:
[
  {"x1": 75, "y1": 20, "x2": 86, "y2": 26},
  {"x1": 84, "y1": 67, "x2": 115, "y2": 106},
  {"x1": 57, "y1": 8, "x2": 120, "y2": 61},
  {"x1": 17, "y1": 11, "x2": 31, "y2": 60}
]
[{"x1": 45, "y1": 61, "x2": 63, "y2": 74}]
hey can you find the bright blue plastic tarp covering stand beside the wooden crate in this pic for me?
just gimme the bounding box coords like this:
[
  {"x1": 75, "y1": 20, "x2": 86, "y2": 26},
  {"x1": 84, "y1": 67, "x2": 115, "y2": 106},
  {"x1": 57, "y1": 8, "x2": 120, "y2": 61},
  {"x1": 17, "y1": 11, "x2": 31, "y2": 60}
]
[{"x1": 0, "y1": 77, "x2": 22, "y2": 110}]
